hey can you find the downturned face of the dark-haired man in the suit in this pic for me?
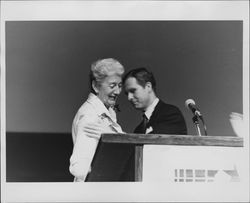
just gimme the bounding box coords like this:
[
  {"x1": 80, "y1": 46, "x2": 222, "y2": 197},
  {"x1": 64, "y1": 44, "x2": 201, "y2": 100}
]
[{"x1": 124, "y1": 77, "x2": 149, "y2": 110}]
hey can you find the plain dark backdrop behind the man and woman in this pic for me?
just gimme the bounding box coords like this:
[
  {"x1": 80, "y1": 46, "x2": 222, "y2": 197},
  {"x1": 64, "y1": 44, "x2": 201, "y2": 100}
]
[{"x1": 6, "y1": 21, "x2": 243, "y2": 181}]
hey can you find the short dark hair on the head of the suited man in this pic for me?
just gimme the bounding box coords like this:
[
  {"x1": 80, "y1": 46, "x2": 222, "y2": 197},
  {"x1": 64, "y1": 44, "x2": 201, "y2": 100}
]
[{"x1": 123, "y1": 67, "x2": 156, "y2": 91}]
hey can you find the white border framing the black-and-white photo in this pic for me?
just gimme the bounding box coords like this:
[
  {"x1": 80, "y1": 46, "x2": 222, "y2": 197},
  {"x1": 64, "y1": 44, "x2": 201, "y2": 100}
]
[{"x1": 1, "y1": 1, "x2": 249, "y2": 202}]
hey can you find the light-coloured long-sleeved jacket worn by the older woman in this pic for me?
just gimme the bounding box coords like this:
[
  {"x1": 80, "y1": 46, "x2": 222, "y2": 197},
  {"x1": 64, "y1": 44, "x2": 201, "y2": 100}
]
[{"x1": 69, "y1": 93, "x2": 123, "y2": 182}]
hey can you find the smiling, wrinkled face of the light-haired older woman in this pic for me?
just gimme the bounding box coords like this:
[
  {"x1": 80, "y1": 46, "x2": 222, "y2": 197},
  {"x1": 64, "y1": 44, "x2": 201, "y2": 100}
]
[{"x1": 95, "y1": 75, "x2": 122, "y2": 108}]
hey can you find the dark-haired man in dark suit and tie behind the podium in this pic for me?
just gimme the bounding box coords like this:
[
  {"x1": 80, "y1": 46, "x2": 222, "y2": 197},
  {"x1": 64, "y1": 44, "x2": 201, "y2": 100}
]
[{"x1": 123, "y1": 68, "x2": 187, "y2": 135}]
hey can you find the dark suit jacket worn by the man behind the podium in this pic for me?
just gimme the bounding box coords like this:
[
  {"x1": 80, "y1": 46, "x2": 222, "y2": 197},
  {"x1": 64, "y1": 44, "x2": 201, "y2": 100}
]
[{"x1": 134, "y1": 100, "x2": 187, "y2": 135}]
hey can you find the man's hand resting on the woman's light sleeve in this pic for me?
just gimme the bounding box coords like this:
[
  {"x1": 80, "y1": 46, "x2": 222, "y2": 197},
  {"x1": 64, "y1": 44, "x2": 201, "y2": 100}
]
[{"x1": 82, "y1": 123, "x2": 113, "y2": 139}]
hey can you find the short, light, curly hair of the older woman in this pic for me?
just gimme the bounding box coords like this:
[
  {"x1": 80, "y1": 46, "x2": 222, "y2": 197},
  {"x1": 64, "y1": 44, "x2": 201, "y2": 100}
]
[{"x1": 89, "y1": 58, "x2": 125, "y2": 93}]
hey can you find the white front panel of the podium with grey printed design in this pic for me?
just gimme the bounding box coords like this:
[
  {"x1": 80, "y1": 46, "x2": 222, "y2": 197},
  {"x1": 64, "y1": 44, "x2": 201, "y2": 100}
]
[{"x1": 142, "y1": 145, "x2": 247, "y2": 182}]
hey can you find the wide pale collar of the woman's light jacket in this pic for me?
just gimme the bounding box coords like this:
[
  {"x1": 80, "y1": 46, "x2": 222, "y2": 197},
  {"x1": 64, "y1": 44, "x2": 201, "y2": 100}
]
[{"x1": 87, "y1": 93, "x2": 116, "y2": 122}]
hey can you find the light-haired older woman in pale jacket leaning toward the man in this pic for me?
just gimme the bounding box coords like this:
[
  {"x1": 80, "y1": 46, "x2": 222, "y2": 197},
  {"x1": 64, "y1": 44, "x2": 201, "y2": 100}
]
[{"x1": 69, "y1": 58, "x2": 124, "y2": 182}]
